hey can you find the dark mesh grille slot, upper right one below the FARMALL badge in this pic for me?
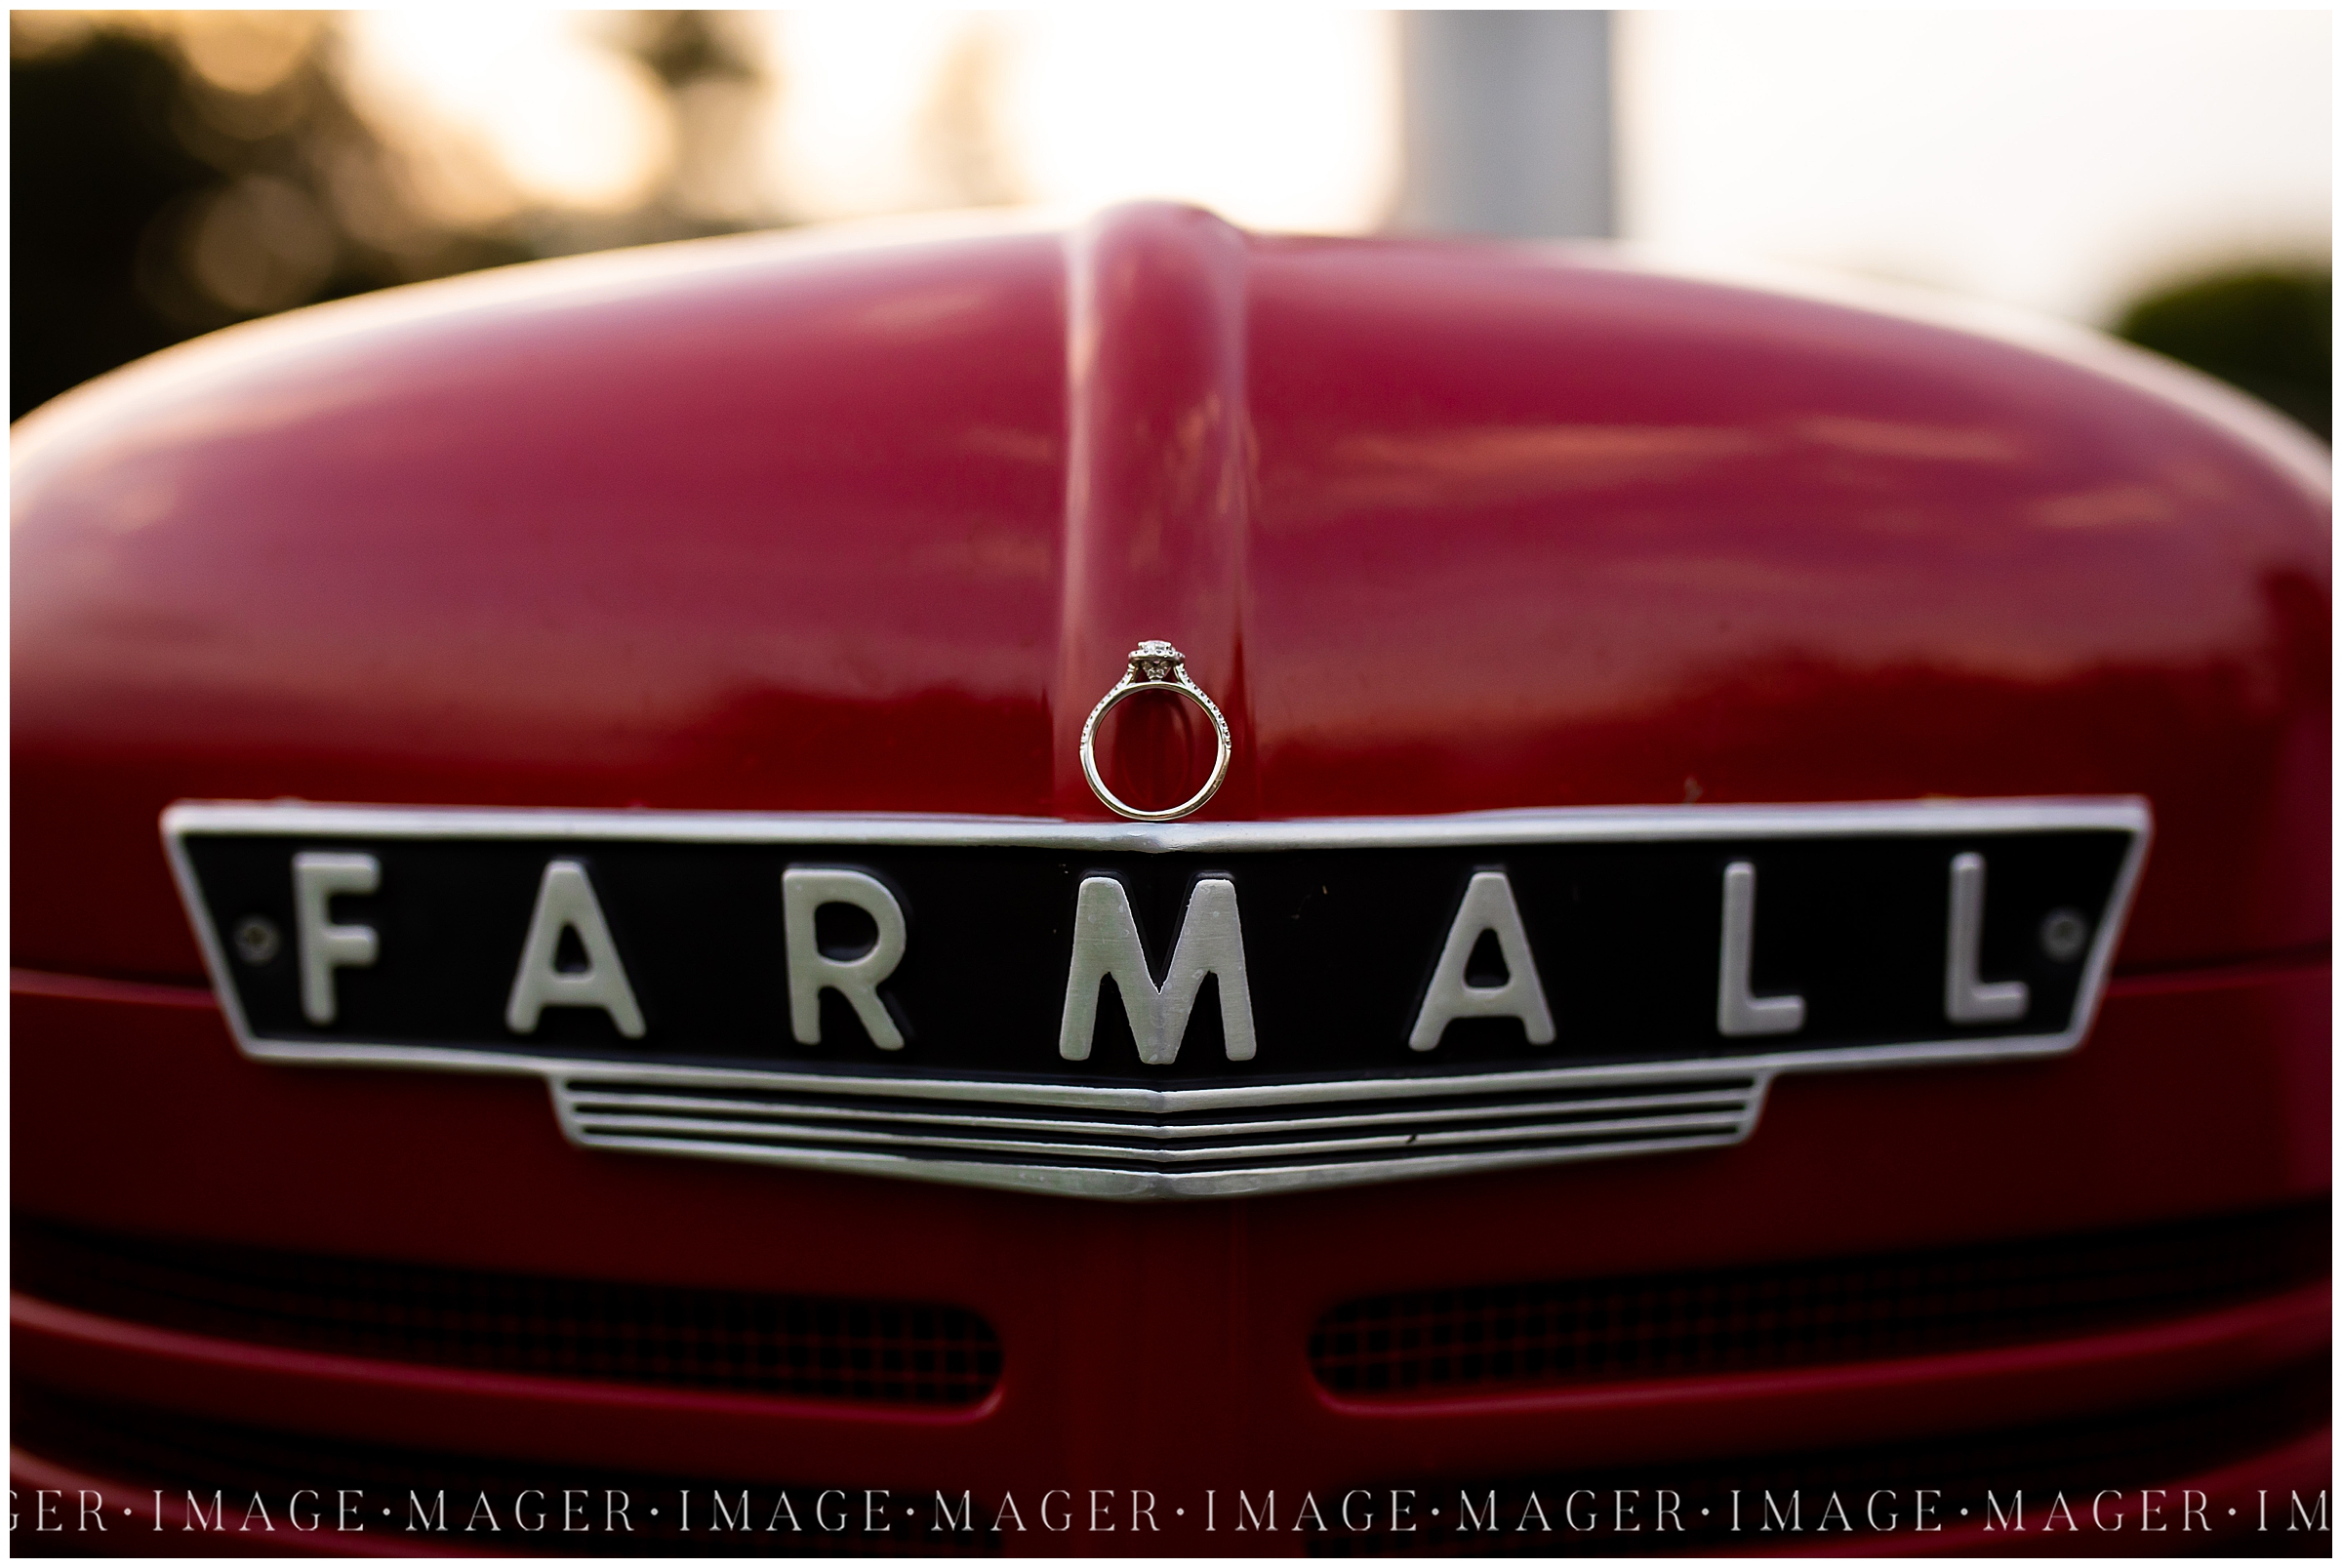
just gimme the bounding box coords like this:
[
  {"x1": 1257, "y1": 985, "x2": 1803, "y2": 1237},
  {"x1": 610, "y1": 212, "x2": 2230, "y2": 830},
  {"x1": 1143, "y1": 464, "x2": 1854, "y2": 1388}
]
[{"x1": 1310, "y1": 1198, "x2": 2332, "y2": 1397}]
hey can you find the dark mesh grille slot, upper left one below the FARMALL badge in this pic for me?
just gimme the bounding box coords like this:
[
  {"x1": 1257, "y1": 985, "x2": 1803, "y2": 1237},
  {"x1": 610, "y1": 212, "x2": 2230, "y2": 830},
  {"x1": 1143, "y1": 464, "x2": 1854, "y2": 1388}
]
[{"x1": 10, "y1": 1215, "x2": 1000, "y2": 1407}]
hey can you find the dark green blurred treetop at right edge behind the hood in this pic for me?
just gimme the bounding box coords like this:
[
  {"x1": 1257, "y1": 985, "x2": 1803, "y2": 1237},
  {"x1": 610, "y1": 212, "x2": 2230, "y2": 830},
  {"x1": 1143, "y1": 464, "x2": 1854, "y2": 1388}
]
[{"x1": 2115, "y1": 266, "x2": 2335, "y2": 442}]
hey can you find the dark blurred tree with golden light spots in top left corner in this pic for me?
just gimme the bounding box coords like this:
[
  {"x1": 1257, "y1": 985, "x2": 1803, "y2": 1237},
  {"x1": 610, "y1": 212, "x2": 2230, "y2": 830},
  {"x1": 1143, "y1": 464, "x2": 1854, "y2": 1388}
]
[{"x1": 10, "y1": 12, "x2": 529, "y2": 419}]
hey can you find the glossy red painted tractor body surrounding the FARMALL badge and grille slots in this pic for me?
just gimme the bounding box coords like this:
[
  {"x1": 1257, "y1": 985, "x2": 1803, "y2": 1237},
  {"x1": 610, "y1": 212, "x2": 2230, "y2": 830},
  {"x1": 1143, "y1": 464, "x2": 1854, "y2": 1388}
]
[{"x1": 12, "y1": 208, "x2": 2330, "y2": 1549}]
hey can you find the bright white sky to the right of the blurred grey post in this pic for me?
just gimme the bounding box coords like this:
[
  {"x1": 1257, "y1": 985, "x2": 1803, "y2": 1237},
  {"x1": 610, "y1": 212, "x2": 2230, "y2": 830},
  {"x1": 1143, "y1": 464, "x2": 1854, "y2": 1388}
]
[{"x1": 1618, "y1": 10, "x2": 2332, "y2": 323}]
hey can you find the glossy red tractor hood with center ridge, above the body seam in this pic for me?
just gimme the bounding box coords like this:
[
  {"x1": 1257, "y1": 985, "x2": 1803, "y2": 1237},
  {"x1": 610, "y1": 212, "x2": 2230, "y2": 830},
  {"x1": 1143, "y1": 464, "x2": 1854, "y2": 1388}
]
[{"x1": 14, "y1": 206, "x2": 2330, "y2": 979}]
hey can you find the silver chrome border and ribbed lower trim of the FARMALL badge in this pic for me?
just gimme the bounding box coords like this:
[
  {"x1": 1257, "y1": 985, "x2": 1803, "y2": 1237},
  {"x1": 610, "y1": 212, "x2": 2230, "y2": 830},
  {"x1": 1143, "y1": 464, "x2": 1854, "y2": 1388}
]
[{"x1": 162, "y1": 795, "x2": 2153, "y2": 1198}]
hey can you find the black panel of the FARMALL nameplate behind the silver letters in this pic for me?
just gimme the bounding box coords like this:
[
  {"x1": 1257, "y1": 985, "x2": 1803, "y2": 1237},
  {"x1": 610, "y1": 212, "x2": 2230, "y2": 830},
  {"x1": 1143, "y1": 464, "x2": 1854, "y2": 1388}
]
[{"x1": 166, "y1": 803, "x2": 2145, "y2": 1088}]
